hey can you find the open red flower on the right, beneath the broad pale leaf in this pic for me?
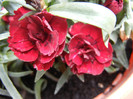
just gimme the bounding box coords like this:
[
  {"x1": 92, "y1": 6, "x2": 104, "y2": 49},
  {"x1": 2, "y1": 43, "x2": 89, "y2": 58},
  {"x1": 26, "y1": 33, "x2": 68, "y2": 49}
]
[{"x1": 65, "y1": 22, "x2": 113, "y2": 75}]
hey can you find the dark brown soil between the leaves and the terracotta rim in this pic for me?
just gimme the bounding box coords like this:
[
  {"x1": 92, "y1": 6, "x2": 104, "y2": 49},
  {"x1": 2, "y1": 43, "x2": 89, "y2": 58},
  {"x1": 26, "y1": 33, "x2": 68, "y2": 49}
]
[{"x1": 42, "y1": 72, "x2": 117, "y2": 99}]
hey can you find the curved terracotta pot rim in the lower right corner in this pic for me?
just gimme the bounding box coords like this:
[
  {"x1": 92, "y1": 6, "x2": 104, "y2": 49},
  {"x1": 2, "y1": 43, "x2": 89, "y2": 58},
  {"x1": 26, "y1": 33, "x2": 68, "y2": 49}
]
[{"x1": 94, "y1": 42, "x2": 133, "y2": 99}]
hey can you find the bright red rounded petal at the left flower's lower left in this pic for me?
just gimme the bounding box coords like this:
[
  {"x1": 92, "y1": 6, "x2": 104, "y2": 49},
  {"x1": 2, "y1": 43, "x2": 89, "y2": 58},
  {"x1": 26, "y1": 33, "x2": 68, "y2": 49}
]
[{"x1": 12, "y1": 49, "x2": 39, "y2": 62}]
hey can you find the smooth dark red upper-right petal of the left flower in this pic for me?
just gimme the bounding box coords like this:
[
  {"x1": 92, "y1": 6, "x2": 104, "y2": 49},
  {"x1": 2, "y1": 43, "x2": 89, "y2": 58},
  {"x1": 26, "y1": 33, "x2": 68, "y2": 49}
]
[{"x1": 50, "y1": 16, "x2": 67, "y2": 45}]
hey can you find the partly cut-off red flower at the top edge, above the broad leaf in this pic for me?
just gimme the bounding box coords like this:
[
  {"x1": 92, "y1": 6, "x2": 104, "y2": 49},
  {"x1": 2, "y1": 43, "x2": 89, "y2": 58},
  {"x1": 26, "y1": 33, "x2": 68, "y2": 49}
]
[{"x1": 104, "y1": 0, "x2": 123, "y2": 14}]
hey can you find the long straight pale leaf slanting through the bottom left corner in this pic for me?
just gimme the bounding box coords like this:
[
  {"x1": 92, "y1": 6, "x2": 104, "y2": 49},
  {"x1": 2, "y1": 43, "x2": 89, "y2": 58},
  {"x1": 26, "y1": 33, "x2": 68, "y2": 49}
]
[{"x1": 0, "y1": 64, "x2": 22, "y2": 99}]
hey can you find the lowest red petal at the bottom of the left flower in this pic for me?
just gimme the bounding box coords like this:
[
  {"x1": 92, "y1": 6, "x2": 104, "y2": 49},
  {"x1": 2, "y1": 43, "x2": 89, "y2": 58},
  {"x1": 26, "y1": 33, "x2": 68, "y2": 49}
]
[{"x1": 33, "y1": 59, "x2": 54, "y2": 71}]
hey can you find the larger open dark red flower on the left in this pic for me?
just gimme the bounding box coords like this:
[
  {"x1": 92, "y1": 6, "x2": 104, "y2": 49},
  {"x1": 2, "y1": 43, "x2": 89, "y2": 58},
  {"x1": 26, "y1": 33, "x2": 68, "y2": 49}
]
[{"x1": 8, "y1": 7, "x2": 67, "y2": 70}]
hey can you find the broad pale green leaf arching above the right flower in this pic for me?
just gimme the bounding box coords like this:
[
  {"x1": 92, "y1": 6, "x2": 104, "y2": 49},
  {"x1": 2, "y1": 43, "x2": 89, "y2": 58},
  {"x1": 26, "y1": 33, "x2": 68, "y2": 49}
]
[{"x1": 49, "y1": 2, "x2": 116, "y2": 34}]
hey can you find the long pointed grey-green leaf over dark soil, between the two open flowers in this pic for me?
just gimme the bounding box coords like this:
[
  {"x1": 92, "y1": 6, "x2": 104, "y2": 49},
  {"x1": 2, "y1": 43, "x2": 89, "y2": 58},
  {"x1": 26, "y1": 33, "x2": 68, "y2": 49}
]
[{"x1": 54, "y1": 67, "x2": 72, "y2": 94}]
